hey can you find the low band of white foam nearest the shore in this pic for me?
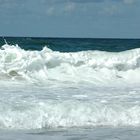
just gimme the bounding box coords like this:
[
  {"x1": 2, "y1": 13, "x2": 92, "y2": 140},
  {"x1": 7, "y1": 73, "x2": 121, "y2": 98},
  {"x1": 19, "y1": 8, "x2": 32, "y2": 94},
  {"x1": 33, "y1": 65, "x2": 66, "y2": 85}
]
[{"x1": 0, "y1": 101, "x2": 140, "y2": 129}]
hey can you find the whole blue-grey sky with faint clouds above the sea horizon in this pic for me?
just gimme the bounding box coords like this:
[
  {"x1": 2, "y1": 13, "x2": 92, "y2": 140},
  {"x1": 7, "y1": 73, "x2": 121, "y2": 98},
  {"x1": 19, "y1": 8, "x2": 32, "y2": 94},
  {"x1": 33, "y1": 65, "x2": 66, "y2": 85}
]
[{"x1": 0, "y1": 0, "x2": 140, "y2": 38}]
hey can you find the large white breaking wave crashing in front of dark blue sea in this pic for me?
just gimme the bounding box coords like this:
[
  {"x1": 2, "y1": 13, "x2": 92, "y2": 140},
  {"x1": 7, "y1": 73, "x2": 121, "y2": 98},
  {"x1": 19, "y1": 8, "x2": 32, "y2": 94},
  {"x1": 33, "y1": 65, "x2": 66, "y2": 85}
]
[{"x1": 0, "y1": 44, "x2": 140, "y2": 85}]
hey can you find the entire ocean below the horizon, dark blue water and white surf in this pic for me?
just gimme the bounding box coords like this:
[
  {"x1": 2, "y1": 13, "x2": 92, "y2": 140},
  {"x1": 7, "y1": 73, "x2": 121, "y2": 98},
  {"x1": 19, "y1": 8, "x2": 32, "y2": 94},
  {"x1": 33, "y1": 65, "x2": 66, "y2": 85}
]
[{"x1": 0, "y1": 37, "x2": 140, "y2": 140}]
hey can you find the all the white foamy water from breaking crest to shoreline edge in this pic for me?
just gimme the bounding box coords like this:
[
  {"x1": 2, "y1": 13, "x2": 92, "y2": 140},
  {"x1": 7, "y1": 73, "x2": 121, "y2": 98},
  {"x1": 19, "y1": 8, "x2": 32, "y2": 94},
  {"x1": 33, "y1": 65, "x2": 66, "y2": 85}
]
[{"x1": 0, "y1": 44, "x2": 140, "y2": 129}]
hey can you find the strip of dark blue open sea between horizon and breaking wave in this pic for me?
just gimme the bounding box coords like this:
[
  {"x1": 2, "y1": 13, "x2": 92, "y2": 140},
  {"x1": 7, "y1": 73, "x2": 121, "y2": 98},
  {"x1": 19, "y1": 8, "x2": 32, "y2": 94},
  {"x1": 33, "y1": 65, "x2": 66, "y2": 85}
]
[{"x1": 0, "y1": 37, "x2": 140, "y2": 52}]
